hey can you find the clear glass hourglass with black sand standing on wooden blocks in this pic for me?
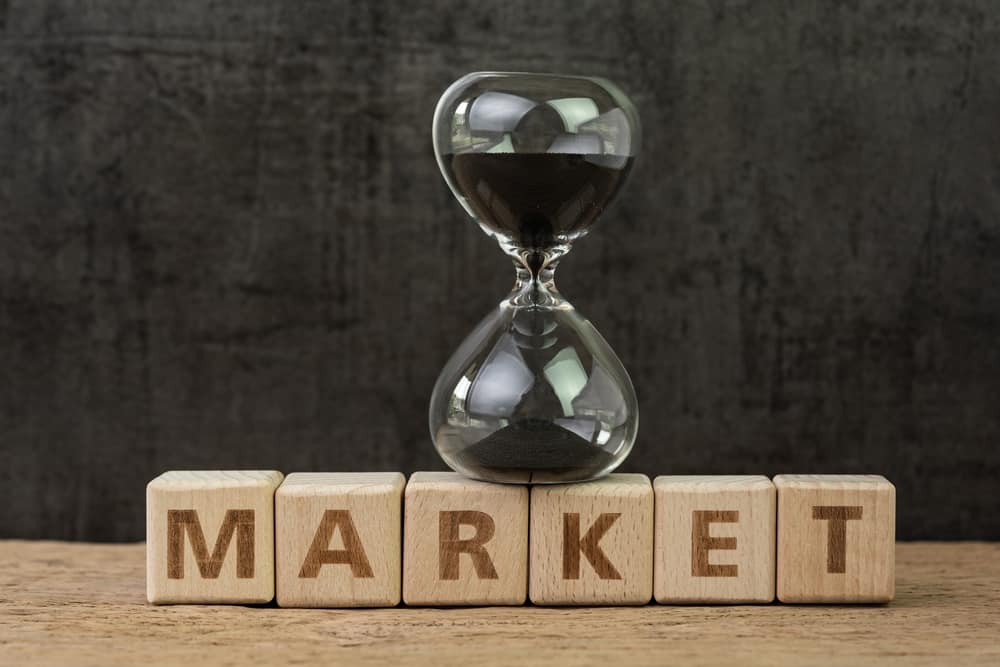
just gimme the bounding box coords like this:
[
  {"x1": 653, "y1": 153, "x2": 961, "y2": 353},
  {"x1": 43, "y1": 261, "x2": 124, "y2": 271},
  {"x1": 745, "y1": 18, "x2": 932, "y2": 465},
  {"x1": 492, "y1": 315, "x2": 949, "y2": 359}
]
[{"x1": 430, "y1": 72, "x2": 639, "y2": 483}]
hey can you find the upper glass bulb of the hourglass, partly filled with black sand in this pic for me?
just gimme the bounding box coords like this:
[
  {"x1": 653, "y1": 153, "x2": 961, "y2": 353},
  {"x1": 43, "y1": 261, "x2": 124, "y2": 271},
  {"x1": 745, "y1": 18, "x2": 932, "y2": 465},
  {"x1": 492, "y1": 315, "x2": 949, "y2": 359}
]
[{"x1": 434, "y1": 72, "x2": 639, "y2": 268}]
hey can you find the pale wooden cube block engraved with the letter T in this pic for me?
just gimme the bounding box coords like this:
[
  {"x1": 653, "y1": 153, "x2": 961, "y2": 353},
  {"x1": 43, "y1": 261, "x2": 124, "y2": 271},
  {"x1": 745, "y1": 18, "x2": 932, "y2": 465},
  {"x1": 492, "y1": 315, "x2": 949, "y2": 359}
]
[{"x1": 774, "y1": 475, "x2": 896, "y2": 602}]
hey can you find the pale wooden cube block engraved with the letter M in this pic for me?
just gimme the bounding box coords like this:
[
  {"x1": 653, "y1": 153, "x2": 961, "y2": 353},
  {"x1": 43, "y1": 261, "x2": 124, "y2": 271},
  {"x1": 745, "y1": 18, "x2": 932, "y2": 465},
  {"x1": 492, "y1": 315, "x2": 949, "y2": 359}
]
[{"x1": 146, "y1": 470, "x2": 282, "y2": 604}]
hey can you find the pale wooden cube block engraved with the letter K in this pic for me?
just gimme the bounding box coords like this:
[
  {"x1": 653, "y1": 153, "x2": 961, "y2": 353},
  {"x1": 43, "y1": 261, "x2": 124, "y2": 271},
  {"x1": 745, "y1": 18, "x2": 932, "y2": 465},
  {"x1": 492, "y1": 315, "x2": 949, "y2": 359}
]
[{"x1": 529, "y1": 474, "x2": 653, "y2": 605}]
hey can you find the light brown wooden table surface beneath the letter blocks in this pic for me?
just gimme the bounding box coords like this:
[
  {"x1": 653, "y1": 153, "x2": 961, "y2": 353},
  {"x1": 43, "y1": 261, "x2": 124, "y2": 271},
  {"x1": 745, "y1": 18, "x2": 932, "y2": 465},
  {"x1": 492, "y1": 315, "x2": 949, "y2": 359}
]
[{"x1": 0, "y1": 541, "x2": 1000, "y2": 667}]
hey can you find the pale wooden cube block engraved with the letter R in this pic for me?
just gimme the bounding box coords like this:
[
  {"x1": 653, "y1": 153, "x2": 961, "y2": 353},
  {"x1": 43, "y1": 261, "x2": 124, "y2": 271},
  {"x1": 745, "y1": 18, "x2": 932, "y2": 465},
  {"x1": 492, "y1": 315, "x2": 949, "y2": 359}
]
[{"x1": 403, "y1": 472, "x2": 528, "y2": 606}]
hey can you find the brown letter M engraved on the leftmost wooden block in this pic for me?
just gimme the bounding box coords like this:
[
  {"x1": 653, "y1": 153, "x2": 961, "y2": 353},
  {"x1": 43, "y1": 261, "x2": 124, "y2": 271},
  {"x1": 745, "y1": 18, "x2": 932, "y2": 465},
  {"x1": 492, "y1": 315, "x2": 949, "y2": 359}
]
[{"x1": 167, "y1": 510, "x2": 254, "y2": 579}]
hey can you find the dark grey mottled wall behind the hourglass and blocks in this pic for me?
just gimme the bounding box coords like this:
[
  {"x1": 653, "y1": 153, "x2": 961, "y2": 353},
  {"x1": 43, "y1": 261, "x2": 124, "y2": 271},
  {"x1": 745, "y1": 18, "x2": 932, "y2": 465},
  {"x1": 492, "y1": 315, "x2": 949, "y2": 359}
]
[{"x1": 0, "y1": 0, "x2": 1000, "y2": 540}]
